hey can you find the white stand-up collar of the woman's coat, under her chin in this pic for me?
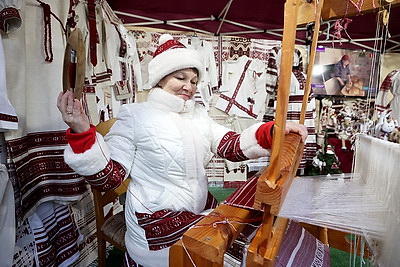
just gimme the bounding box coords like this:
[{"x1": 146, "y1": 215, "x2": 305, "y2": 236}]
[{"x1": 147, "y1": 88, "x2": 195, "y2": 113}]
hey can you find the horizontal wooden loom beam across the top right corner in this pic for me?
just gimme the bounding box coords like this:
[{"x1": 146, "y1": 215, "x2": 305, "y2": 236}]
[{"x1": 297, "y1": 0, "x2": 400, "y2": 25}]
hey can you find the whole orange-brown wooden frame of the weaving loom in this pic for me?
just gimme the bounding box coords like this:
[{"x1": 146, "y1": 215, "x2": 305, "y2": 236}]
[{"x1": 170, "y1": 0, "x2": 400, "y2": 267}]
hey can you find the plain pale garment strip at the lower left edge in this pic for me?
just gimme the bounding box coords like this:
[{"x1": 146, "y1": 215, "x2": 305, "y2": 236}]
[{"x1": 0, "y1": 164, "x2": 15, "y2": 266}]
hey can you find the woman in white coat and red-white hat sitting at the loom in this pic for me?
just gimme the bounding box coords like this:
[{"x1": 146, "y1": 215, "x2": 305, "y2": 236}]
[{"x1": 57, "y1": 36, "x2": 307, "y2": 266}]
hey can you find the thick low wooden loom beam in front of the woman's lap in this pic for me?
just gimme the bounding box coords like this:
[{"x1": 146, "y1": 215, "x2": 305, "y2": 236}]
[{"x1": 170, "y1": 204, "x2": 256, "y2": 267}]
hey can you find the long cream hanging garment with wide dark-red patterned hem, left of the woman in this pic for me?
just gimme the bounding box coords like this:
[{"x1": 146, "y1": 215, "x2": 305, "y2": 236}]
[{"x1": 3, "y1": 0, "x2": 87, "y2": 218}]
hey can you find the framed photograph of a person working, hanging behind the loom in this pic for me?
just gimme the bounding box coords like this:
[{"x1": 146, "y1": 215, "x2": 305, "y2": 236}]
[{"x1": 311, "y1": 46, "x2": 379, "y2": 97}]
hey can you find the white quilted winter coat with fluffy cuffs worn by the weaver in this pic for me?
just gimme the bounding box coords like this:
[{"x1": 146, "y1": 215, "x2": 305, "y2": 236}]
[{"x1": 64, "y1": 88, "x2": 269, "y2": 266}]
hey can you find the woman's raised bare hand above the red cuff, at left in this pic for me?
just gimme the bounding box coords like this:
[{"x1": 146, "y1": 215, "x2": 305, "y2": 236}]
[{"x1": 57, "y1": 91, "x2": 90, "y2": 133}]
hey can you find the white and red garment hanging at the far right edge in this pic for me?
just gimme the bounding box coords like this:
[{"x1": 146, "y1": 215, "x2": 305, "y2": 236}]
[{"x1": 376, "y1": 69, "x2": 400, "y2": 122}]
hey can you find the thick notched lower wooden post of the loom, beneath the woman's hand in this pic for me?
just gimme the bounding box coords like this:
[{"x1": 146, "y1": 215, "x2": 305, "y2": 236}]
[{"x1": 246, "y1": 133, "x2": 304, "y2": 266}]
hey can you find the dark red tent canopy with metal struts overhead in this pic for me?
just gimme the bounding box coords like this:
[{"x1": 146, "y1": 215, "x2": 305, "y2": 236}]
[{"x1": 108, "y1": 0, "x2": 400, "y2": 52}]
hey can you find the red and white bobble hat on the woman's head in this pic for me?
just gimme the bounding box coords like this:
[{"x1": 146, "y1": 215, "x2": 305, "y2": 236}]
[{"x1": 147, "y1": 34, "x2": 203, "y2": 89}]
